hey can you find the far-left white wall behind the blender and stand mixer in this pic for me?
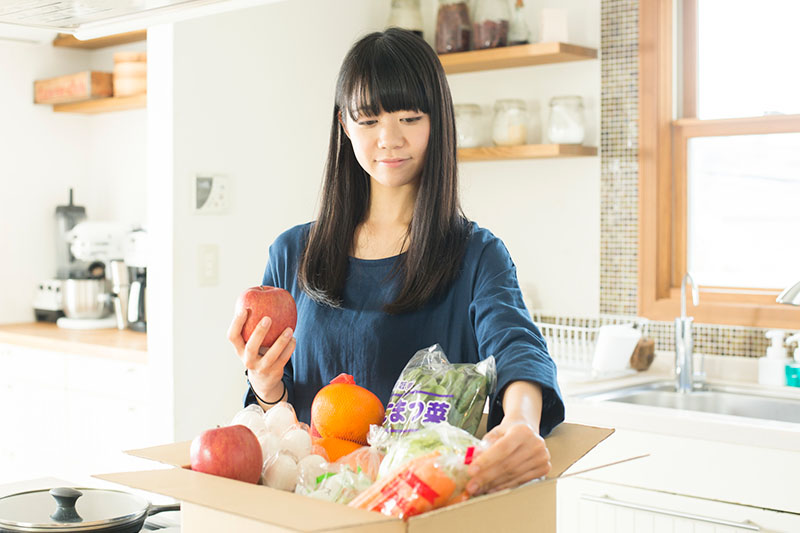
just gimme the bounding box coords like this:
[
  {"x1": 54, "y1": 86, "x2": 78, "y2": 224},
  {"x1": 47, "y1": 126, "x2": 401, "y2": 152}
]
[{"x1": 0, "y1": 40, "x2": 146, "y2": 323}]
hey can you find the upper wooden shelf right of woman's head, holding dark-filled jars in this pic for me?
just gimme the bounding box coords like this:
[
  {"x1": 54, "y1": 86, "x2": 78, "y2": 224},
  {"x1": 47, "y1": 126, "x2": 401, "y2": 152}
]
[{"x1": 439, "y1": 42, "x2": 597, "y2": 74}]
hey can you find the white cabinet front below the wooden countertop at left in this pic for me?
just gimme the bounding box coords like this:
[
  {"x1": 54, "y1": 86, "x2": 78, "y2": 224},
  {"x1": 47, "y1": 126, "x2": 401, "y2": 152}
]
[{"x1": 0, "y1": 344, "x2": 147, "y2": 481}]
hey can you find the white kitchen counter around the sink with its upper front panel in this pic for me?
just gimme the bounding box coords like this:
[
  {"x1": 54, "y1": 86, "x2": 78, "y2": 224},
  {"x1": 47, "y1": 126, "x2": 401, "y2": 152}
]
[{"x1": 561, "y1": 353, "x2": 800, "y2": 513}]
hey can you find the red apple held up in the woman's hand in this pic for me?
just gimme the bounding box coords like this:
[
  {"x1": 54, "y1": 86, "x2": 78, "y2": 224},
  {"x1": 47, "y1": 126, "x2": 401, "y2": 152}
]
[{"x1": 236, "y1": 285, "x2": 297, "y2": 348}]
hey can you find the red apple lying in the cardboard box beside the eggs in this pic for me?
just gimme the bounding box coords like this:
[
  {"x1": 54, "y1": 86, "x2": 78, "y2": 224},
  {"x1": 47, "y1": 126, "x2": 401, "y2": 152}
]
[{"x1": 189, "y1": 425, "x2": 263, "y2": 483}]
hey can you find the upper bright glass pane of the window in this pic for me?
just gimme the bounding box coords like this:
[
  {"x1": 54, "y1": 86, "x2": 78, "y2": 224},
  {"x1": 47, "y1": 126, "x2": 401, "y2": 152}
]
[{"x1": 697, "y1": 0, "x2": 800, "y2": 119}]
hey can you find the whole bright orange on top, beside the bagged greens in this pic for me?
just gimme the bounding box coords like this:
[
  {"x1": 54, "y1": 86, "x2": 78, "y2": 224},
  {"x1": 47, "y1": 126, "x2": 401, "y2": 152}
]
[{"x1": 311, "y1": 374, "x2": 384, "y2": 444}]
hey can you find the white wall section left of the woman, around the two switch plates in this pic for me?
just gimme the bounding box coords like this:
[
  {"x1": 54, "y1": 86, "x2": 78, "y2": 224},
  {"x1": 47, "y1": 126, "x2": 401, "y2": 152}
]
[{"x1": 148, "y1": 0, "x2": 388, "y2": 440}]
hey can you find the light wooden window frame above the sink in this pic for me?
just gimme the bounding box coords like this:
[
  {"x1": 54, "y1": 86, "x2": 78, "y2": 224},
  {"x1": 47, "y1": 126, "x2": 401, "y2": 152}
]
[{"x1": 638, "y1": 0, "x2": 800, "y2": 329}]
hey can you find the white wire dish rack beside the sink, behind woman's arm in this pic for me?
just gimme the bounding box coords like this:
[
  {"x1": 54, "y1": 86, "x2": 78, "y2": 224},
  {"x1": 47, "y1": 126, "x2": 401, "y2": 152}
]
[{"x1": 531, "y1": 311, "x2": 648, "y2": 373}]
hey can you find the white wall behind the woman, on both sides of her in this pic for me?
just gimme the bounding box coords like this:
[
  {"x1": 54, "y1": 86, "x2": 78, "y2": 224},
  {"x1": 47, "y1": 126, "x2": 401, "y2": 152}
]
[{"x1": 148, "y1": 0, "x2": 600, "y2": 440}]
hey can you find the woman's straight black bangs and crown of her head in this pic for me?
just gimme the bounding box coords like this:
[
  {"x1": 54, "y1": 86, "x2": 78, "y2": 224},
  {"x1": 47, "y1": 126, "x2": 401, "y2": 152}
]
[{"x1": 337, "y1": 34, "x2": 432, "y2": 120}]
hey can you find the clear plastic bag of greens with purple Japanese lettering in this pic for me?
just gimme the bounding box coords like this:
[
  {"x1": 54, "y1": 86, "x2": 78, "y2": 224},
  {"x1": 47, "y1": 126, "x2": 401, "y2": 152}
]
[{"x1": 383, "y1": 344, "x2": 497, "y2": 435}]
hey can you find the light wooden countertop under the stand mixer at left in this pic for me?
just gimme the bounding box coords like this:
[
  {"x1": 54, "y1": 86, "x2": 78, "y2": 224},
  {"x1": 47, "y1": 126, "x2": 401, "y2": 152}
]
[{"x1": 0, "y1": 322, "x2": 147, "y2": 364}]
